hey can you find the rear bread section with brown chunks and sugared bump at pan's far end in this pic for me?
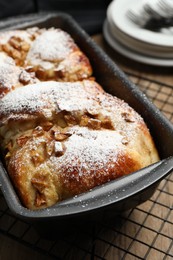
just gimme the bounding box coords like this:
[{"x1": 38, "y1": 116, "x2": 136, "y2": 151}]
[{"x1": 0, "y1": 28, "x2": 92, "y2": 81}]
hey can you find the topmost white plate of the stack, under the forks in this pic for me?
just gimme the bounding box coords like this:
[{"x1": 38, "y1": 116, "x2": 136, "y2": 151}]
[{"x1": 108, "y1": 0, "x2": 173, "y2": 47}]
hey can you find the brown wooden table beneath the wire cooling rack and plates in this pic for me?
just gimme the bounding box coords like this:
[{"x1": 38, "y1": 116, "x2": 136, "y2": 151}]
[{"x1": 0, "y1": 35, "x2": 173, "y2": 260}]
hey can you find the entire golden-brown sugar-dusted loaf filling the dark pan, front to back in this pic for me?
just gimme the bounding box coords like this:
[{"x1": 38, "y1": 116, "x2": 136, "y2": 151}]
[{"x1": 0, "y1": 28, "x2": 159, "y2": 209}]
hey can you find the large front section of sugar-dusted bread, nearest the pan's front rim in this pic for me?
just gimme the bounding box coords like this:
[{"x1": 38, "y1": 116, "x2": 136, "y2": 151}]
[{"x1": 0, "y1": 26, "x2": 159, "y2": 209}]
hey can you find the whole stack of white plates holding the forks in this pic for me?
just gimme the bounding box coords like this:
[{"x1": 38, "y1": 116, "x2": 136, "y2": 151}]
[{"x1": 103, "y1": 0, "x2": 173, "y2": 66}]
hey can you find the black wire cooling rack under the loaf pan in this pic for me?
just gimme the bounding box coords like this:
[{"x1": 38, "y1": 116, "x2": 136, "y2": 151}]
[{"x1": 0, "y1": 74, "x2": 173, "y2": 260}]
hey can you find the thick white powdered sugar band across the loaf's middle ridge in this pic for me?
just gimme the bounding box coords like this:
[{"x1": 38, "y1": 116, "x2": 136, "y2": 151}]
[{"x1": 0, "y1": 81, "x2": 100, "y2": 119}]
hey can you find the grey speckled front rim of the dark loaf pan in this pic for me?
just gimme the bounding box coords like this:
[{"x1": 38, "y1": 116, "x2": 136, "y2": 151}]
[{"x1": 0, "y1": 157, "x2": 173, "y2": 219}]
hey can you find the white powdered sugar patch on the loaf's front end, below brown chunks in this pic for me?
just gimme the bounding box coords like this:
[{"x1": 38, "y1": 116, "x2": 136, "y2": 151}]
[{"x1": 50, "y1": 127, "x2": 124, "y2": 175}]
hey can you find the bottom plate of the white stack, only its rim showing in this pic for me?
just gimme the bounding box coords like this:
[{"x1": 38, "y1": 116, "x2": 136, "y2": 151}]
[{"x1": 103, "y1": 20, "x2": 173, "y2": 67}]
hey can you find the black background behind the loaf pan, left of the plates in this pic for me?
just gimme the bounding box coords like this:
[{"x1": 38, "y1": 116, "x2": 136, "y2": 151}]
[{"x1": 0, "y1": 0, "x2": 111, "y2": 34}]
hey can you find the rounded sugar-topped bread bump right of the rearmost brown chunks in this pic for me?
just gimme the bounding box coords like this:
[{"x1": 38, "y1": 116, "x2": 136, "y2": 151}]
[{"x1": 25, "y1": 28, "x2": 92, "y2": 81}]
